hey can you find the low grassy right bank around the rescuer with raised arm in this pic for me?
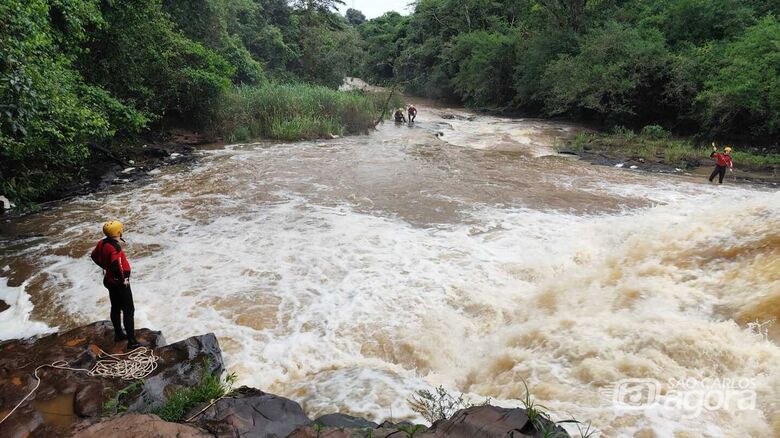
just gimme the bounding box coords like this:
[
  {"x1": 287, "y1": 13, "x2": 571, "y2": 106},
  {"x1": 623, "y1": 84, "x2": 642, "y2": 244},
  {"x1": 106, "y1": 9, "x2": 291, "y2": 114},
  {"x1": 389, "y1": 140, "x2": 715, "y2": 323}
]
[{"x1": 557, "y1": 127, "x2": 780, "y2": 185}]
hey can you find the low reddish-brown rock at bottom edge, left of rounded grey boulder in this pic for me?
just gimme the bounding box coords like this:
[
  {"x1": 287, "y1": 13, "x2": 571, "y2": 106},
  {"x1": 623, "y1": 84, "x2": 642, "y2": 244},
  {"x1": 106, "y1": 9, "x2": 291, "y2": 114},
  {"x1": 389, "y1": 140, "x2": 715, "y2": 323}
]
[{"x1": 73, "y1": 414, "x2": 212, "y2": 438}]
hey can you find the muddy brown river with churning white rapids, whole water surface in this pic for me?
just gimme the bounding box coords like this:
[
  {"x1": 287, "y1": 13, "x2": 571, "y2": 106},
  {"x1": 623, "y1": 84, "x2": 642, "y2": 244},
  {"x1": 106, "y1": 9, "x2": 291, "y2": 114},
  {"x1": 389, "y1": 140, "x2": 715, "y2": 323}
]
[{"x1": 0, "y1": 106, "x2": 780, "y2": 438}]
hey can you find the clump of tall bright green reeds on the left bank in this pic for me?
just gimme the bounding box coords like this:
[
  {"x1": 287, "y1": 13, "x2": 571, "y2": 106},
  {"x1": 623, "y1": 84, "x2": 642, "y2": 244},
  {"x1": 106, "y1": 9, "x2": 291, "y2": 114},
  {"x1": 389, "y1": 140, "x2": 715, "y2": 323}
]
[{"x1": 212, "y1": 84, "x2": 400, "y2": 142}]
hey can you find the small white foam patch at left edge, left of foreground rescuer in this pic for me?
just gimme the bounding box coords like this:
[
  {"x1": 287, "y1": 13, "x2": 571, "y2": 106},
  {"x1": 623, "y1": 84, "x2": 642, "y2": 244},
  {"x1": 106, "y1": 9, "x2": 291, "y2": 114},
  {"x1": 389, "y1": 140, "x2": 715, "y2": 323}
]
[{"x1": 0, "y1": 277, "x2": 57, "y2": 341}]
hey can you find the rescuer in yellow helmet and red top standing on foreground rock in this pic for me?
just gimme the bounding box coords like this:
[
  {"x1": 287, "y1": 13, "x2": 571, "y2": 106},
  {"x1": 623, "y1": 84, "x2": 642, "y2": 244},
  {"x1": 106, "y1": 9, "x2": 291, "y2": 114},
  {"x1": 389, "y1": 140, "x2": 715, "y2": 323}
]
[{"x1": 92, "y1": 221, "x2": 141, "y2": 350}]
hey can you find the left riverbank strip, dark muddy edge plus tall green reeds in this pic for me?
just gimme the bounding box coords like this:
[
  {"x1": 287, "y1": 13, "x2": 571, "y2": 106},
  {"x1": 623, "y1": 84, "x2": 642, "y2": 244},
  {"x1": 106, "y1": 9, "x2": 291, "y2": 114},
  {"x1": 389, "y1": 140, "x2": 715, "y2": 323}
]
[{"x1": 0, "y1": 84, "x2": 400, "y2": 214}]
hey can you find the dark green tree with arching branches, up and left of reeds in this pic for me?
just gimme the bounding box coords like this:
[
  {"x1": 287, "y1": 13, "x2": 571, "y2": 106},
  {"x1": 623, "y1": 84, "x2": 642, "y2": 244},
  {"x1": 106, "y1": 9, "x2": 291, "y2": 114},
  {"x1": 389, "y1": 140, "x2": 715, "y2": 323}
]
[{"x1": 81, "y1": 0, "x2": 235, "y2": 119}]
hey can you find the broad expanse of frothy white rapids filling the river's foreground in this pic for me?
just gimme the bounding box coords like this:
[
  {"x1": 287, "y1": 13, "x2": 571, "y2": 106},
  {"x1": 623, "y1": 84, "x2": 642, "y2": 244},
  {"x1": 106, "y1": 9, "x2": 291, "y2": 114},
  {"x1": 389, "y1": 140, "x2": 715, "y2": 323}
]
[{"x1": 0, "y1": 132, "x2": 780, "y2": 437}]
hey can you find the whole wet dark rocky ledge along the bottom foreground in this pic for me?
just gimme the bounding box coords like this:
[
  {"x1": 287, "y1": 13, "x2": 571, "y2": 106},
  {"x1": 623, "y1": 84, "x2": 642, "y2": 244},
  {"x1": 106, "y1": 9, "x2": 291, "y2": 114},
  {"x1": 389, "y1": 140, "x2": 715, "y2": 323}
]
[{"x1": 0, "y1": 321, "x2": 568, "y2": 438}]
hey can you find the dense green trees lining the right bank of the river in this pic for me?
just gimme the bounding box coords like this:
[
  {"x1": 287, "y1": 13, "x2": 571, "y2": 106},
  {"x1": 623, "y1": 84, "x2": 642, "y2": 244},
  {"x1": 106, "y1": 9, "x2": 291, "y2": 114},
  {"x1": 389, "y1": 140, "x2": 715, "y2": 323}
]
[{"x1": 358, "y1": 0, "x2": 780, "y2": 147}]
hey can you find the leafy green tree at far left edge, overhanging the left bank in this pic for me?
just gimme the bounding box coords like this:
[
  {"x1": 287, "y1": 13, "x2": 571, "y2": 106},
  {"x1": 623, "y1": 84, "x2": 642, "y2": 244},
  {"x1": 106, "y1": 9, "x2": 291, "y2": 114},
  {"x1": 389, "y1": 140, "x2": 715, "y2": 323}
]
[{"x1": 0, "y1": 0, "x2": 146, "y2": 202}]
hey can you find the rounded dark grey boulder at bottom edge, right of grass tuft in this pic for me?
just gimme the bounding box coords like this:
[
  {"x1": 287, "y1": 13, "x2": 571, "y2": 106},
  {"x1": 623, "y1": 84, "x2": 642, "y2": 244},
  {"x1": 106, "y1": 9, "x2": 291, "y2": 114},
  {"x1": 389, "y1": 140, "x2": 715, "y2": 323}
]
[{"x1": 196, "y1": 387, "x2": 311, "y2": 438}]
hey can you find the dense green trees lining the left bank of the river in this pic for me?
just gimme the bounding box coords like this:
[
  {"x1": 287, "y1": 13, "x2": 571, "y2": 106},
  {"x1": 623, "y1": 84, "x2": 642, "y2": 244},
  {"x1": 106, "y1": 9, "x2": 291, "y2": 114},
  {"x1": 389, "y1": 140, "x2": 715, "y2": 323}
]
[{"x1": 0, "y1": 0, "x2": 371, "y2": 202}]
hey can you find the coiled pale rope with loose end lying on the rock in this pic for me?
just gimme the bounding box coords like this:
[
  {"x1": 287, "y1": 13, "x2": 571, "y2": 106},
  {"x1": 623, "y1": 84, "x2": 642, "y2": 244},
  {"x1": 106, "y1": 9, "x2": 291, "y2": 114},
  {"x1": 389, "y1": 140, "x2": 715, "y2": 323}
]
[{"x1": 0, "y1": 347, "x2": 160, "y2": 424}]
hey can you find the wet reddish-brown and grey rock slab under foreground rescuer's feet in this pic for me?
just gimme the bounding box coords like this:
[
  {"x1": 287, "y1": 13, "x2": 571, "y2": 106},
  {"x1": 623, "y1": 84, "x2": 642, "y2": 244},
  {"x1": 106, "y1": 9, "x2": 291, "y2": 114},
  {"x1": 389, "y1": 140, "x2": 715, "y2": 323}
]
[{"x1": 0, "y1": 321, "x2": 224, "y2": 438}]
